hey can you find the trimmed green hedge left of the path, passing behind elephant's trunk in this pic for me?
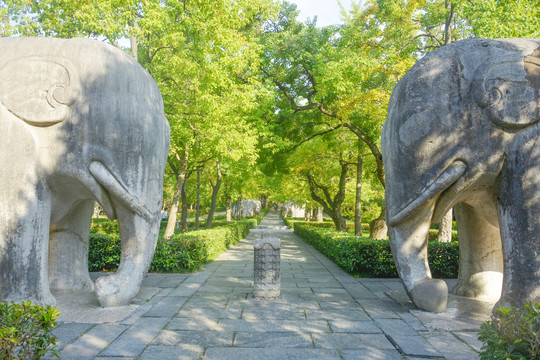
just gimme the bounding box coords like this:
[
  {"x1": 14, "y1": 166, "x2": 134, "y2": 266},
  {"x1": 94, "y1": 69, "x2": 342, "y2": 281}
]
[{"x1": 88, "y1": 219, "x2": 260, "y2": 272}]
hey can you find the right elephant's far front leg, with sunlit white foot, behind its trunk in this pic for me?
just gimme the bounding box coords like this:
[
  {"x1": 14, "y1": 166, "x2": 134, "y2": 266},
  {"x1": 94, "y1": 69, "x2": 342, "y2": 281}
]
[{"x1": 452, "y1": 204, "x2": 503, "y2": 301}]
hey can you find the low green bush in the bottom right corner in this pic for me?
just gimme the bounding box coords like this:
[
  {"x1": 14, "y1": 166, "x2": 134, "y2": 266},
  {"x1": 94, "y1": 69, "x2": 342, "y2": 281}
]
[{"x1": 478, "y1": 303, "x2": 540, "y2": 360}]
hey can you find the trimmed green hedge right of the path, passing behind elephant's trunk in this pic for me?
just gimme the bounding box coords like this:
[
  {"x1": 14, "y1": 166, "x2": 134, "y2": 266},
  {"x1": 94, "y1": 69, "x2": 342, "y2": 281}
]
[{"x1": 294, "y1": 222, "x2": 459, "y2": 278}]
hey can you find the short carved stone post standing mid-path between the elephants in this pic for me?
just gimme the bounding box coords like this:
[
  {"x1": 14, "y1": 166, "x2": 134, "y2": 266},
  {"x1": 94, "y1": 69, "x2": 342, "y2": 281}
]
[{"x1": 253, "y1": 231, "x2": 281, "y2": 299}]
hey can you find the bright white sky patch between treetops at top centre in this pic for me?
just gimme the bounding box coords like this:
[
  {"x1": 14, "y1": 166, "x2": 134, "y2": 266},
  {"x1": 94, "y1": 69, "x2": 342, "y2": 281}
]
[{"x1": 288, "y1": 0, "x2": 353, "y2": 27}]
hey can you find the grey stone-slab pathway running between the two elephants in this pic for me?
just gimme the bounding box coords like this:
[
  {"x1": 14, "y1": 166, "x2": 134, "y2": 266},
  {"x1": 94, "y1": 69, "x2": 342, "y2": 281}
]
[{"x1": 48, "y1": 211, "x2": 493, "y2": 360}]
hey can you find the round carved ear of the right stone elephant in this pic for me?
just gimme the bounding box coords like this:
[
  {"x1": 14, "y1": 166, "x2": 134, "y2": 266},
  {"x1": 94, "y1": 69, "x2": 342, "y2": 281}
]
[{"x1": 471, "y1": 49, "x2": 540, "y2": 130}]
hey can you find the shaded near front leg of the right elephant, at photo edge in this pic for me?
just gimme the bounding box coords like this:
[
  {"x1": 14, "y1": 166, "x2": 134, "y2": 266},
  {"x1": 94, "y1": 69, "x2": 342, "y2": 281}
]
[{"x1": 497, "y1": 134, "x2": 540, "y2": 306}]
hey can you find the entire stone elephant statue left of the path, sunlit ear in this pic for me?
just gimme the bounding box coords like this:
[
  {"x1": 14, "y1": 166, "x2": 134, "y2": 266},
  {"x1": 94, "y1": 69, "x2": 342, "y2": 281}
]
[{"x1": 0, "y1": 38, "x2": 170, "y2": 306}]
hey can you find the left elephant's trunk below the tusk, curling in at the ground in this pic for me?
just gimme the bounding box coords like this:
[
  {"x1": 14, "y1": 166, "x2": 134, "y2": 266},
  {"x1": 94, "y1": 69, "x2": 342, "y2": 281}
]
[{"x1": 95, "y1": 201, "x2": 160, "y2": 307}]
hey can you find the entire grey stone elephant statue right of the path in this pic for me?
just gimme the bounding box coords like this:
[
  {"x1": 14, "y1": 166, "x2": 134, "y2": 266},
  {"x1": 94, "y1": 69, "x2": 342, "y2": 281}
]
[{"x1": 382, "y1": 39, "x2": 540, "y2": 312}]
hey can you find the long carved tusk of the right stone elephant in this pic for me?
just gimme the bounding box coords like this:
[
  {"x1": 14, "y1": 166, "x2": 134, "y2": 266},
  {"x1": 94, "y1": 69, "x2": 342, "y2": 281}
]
[{"x1": 388, "y1": 160, "x2": 467, "y2": 226}]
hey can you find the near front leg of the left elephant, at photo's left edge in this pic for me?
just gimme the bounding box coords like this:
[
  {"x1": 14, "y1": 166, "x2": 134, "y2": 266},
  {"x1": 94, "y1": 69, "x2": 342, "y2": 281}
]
[{"x1": 0, "y1": 183, "x2": 55, "y2": 305}]
